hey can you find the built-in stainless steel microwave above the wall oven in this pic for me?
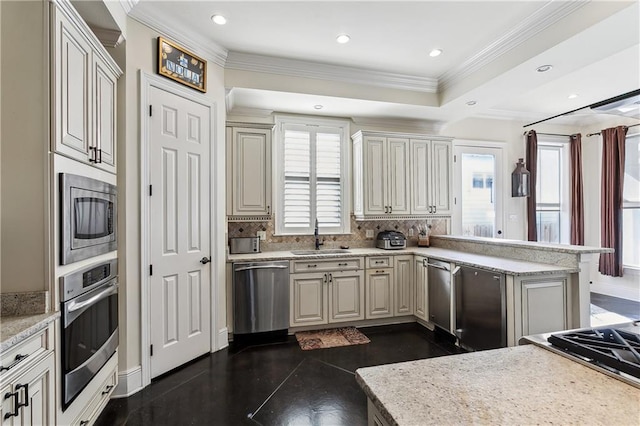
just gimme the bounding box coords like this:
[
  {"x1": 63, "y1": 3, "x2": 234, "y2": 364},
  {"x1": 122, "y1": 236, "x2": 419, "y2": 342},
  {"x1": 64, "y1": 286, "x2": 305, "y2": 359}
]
[{"x1": 60, "y1": 173, "x2": 118, "y2": 265}]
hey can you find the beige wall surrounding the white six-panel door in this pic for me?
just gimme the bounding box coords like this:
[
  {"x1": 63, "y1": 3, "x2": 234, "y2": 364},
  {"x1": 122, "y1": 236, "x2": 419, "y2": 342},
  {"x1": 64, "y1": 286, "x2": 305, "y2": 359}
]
[{"x1": 118, "y1": 19, "x2": 226, "y2": 371}]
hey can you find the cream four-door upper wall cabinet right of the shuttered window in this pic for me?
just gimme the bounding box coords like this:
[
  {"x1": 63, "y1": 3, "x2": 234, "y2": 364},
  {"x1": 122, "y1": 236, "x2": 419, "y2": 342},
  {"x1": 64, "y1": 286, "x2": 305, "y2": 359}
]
[{"x1": 352, "y1": 131, "x2": 452, "y2": 218}]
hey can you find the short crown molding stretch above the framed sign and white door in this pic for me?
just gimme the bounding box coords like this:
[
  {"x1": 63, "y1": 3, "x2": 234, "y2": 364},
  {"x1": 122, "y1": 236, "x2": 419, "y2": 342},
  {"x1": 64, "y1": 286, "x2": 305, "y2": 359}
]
[{"x1": 129, "y1": 8, "x2": 228, "y2": 67}]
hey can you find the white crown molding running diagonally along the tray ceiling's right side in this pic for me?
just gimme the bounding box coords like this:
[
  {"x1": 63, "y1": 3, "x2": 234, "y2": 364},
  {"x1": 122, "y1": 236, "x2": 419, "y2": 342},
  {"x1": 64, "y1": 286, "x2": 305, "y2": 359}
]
[{"x1": 438, "y1": 0, "x2": 591, "y2": 92}]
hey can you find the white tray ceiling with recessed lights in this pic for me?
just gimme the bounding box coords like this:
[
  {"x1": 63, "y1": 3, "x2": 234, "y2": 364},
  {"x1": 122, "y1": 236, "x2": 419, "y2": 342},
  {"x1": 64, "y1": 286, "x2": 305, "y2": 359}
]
[{"x1": 129, "y1": 0, "x2": 640, "y2": 129}]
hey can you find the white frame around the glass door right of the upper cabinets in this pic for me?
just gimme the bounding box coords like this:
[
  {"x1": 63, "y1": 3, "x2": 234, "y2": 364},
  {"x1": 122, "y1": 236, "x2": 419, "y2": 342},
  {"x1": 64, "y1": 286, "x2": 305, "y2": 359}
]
[{"x1": 451, "y1": 139, "x2": 510, "y2": 238}]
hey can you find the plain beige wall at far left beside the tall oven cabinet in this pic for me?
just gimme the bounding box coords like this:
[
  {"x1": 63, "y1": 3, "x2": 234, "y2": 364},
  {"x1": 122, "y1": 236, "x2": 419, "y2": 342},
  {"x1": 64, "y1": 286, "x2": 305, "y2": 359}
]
[{"x1": 0, "y1": 1, "x2": 50, "y2": 293}]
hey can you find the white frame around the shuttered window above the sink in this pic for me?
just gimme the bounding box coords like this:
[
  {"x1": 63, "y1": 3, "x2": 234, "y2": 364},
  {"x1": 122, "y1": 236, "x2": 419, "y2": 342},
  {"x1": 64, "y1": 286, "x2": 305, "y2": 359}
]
[{"x1": 273, "y1": 115, "x2": 351, "y2": 236}]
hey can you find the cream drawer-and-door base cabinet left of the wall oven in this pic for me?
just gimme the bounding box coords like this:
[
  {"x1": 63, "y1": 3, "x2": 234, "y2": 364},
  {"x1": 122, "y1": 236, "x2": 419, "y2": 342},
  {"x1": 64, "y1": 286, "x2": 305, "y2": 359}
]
[{"x1": 0, "y1": 324, "x2": 56, "y2": 426}]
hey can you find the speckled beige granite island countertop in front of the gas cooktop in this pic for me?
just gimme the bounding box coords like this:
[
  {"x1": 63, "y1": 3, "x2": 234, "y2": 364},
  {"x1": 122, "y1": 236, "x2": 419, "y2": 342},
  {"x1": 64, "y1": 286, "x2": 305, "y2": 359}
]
[{"x1": 356, "y1": 345, "x2": 640, "y2": 425}]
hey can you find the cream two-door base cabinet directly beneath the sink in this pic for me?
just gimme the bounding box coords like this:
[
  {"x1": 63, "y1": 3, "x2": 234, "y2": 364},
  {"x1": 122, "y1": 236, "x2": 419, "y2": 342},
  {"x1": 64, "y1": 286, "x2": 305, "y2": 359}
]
[{"x1": 290, "y1": 258, "x2": 365, "y2": 327}]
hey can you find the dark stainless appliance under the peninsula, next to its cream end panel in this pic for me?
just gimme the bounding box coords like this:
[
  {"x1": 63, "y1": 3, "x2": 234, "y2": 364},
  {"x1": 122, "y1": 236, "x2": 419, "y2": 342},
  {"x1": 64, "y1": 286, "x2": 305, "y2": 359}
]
[{"x1": 456, "y1": 267, "x2": 507, "y2": 350}]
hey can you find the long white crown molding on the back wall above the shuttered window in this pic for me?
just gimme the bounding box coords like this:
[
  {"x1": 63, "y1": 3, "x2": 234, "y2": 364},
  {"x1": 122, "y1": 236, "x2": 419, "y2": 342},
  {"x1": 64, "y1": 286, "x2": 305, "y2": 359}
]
[{"x1": 225, "y1": 51, "x2": 438, "y2": 93}]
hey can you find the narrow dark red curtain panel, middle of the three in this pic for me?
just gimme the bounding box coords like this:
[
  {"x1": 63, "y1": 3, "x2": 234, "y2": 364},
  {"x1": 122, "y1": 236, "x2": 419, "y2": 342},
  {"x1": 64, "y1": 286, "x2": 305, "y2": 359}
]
[{"x1": 569, "y1": 133, "x2": 584, "y2": 246}]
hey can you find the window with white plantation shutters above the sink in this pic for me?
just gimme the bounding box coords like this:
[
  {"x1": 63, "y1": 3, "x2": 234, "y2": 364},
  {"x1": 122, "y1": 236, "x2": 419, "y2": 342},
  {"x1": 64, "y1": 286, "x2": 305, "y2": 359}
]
[{"x1": 274, "y1": 116, "x2": 350, "y2": 235}]
